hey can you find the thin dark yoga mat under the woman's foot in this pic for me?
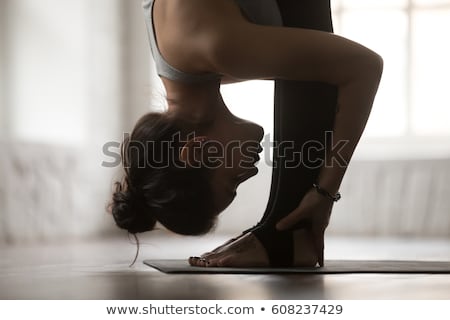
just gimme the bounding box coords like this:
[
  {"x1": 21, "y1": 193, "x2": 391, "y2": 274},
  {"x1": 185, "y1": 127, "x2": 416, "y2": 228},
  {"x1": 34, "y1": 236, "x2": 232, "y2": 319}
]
[{"x1": 144, "y1": 260, "x2": 450, "y2": 274}]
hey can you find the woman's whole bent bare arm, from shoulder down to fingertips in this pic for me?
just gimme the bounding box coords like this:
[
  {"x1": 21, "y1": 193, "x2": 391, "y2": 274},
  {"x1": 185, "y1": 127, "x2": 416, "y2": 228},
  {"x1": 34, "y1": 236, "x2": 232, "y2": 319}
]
[{"x1": 206, "y1": 20, "x2": 383, "y2": 265}]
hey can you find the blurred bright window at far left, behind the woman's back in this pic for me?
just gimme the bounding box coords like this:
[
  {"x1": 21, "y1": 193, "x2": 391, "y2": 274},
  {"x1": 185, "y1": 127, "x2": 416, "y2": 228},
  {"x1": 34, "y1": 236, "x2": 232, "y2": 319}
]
[{"x1": 0, "y1": 0, "x2": 89, "y2": 143}]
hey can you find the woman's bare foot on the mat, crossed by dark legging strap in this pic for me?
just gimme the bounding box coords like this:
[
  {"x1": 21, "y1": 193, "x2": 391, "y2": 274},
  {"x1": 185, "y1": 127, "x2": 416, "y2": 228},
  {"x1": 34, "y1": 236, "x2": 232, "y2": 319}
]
[{"x1": 189, "y1": 230, "x2": 317, "y2": 267}]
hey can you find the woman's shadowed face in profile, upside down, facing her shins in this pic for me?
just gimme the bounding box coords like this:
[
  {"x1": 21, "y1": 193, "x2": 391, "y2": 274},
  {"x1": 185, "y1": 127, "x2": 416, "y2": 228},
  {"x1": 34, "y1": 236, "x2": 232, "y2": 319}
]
[{"x1": 202, "y1": 110, "x2": 264, "y2": 214}]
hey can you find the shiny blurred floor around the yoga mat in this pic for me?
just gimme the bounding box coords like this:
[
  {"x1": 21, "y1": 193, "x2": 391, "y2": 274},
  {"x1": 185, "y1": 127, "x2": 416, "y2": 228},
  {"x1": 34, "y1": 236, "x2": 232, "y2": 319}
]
[{"x1": 0, "y1": 235, "x2": 450, "y2": 300}]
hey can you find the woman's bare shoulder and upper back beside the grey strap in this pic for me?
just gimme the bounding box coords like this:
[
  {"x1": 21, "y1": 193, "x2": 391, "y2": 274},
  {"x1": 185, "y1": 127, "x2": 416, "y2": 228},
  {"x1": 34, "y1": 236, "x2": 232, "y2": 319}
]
[{"x1": 153, "y1": 0, "x2": 250, "y2": 73}]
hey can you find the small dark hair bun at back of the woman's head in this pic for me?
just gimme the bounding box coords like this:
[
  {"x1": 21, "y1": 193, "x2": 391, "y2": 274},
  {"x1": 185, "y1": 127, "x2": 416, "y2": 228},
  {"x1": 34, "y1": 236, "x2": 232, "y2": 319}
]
[{"x1": 111, "y1": 182, "x2": 156, "y2": 234}]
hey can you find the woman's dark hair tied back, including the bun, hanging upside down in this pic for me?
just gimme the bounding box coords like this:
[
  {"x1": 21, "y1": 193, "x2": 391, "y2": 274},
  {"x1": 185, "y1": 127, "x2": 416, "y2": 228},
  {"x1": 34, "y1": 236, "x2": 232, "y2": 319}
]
[{"x1": 110, "y1": 112, "x2": 216, "y2": 235}]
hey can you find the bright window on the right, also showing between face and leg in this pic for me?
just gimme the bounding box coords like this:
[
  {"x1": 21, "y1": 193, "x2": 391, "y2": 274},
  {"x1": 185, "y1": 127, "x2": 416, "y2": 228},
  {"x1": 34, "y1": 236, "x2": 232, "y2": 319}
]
[{"x1": 223, "y1": 0, "x2": 450, "y2": 157}]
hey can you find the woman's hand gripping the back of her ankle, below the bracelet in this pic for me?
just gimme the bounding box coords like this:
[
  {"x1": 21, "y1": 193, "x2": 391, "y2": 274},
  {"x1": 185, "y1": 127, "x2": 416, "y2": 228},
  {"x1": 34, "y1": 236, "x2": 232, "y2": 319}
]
[{"x1": 277, "y1": 188, "x2": 333, "y2": 267}]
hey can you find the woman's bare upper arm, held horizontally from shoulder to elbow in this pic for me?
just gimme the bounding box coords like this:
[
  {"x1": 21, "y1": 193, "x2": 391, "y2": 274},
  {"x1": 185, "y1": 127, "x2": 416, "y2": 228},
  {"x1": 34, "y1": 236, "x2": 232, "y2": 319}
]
[{"x1": 206, "y1": 22, "x2": 381, "y2": 86}]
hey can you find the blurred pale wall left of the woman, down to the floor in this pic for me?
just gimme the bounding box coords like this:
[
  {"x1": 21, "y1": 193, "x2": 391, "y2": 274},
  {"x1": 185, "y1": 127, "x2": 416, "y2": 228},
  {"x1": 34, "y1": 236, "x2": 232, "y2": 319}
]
[{"x1": 0, "y1": 0, "x2": 152, "y2": 241}]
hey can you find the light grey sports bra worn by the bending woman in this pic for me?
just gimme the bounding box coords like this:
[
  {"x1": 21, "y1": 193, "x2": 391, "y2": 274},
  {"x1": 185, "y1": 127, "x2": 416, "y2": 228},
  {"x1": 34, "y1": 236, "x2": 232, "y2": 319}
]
[{"x1": 142, "y1": 0, "x2": 282, "y2": 83}]
